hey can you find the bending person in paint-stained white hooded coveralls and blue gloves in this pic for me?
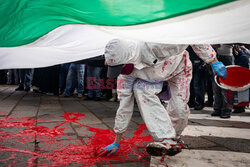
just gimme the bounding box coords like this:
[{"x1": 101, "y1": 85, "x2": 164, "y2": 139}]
[{"x1": 97, "y1": 39, "x2": 227, "y2": 156}]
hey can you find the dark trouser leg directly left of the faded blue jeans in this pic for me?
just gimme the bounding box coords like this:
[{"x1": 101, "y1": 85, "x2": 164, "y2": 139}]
[{"x1": 59, "y1": 63, "x2": 70, "y2": 94}]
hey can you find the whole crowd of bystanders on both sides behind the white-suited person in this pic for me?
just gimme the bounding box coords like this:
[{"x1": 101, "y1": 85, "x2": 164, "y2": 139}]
[{"x1": 0, "y1": 44, "x2": 250, "y2": 118}]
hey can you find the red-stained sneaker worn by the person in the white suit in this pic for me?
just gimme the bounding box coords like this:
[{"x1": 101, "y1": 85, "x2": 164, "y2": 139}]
[{"x1": 147, "y1": 139, "x2": 181, "y2": 156}]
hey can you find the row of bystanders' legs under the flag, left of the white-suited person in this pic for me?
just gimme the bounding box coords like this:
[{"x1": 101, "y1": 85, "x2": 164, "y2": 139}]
[{"x1": 0, "y1": 55, "x2": 117, "y2": 101}]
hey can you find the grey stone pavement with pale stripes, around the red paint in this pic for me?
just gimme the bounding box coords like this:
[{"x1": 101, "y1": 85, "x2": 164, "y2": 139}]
[{"x1": 0, "y1": 85, "x2": 250, "y2": 167}]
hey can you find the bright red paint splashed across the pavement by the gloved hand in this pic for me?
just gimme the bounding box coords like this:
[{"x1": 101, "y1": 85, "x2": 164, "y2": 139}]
[{"x1": 0, "y1": 113, "x2": 152, "y2": 166}]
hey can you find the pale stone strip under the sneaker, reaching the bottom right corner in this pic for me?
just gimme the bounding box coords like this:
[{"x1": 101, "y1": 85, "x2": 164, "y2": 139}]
[{"x1": 150, "y1": 150, "x2": 250, "y2": 167}]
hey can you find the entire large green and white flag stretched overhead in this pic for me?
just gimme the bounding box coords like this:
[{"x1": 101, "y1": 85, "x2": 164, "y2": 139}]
[{"x1": 0, "y1": 0, "x2": 250, "y2": 69}]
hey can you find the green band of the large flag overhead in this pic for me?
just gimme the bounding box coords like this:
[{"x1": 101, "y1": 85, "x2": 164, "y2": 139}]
[{"x1": 0, "y1": 0, "x2": 234, "y2": 47}]
